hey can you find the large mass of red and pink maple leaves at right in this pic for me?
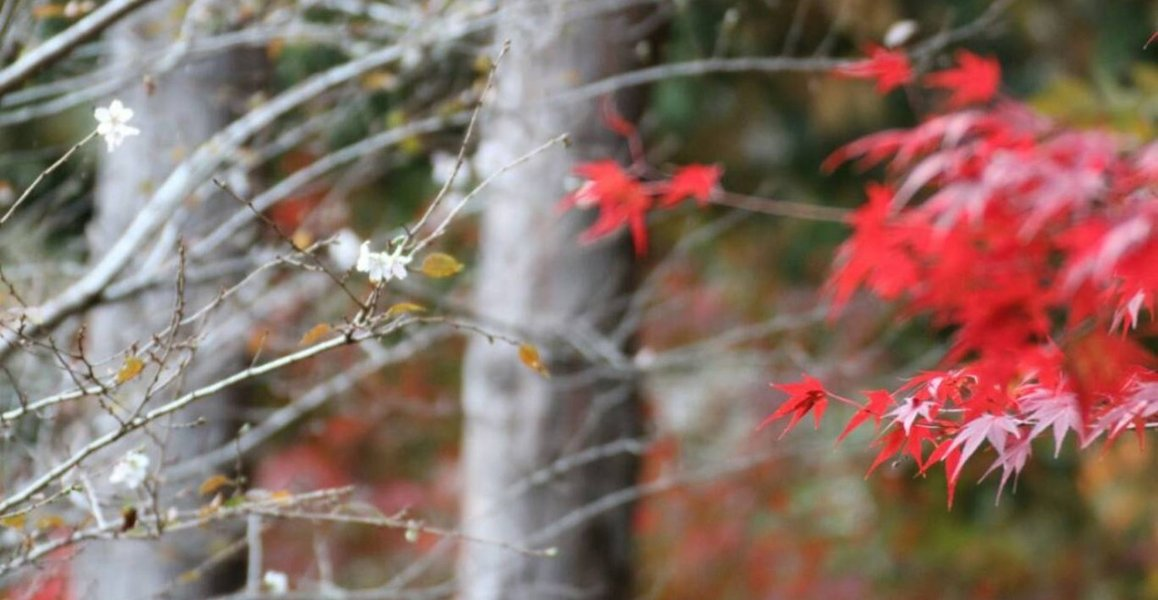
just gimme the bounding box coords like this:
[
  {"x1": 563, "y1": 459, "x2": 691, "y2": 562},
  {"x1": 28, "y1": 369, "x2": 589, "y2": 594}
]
[{"x1": 762, "y1": 49, "x2": 1158, "y2": 504}]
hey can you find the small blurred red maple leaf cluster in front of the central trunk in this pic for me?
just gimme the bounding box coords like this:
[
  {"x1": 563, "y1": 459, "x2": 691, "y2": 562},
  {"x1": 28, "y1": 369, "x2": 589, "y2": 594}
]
[{"x1": 559, "y1": 103, "x2": 724, "y2": 256}]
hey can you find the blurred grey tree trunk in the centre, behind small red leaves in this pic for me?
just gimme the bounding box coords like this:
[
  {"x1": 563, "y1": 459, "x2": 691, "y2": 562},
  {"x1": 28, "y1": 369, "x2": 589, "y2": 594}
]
[{"x1": 459, "y1": 0, "x2": 642, "y2": 600}]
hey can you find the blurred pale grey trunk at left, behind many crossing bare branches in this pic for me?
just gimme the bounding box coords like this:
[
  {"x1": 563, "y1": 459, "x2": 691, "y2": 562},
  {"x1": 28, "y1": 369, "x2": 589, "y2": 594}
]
[{"x1": 73, "y1": 1, "x2": 264, "y2": 599}]
